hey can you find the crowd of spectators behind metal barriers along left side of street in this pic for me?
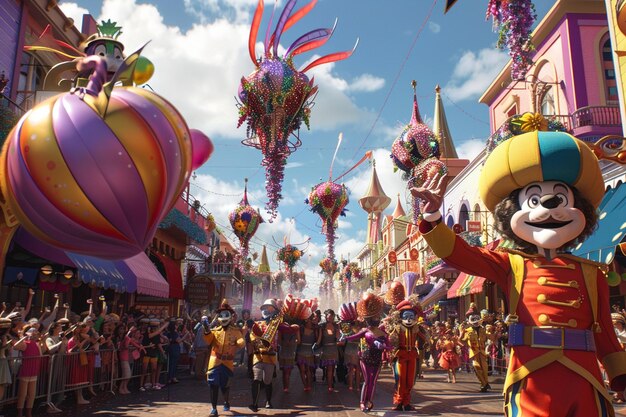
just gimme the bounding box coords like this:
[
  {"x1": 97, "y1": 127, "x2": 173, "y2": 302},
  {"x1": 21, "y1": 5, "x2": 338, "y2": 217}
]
[{"x1": 0, "y1": 290, "x2": 197, "y2": 417}]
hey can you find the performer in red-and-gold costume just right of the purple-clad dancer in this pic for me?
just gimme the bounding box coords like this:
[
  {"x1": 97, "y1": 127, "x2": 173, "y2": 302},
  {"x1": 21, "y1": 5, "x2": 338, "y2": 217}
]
[{"x1": 387, "y1": 295, "x2": 422, "y2": 411}]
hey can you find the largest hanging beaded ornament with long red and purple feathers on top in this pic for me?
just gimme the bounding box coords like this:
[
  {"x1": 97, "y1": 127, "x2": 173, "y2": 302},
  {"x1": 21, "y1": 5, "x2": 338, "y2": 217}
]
[{"x1": 238, "y1": 0, "x2": 358, "y2": 222}]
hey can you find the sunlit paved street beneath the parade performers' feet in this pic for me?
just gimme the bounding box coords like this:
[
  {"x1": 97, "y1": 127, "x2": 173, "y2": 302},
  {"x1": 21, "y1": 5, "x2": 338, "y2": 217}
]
[{"x1": 24, "y1": 367, "x2": 626, "y2": 417}]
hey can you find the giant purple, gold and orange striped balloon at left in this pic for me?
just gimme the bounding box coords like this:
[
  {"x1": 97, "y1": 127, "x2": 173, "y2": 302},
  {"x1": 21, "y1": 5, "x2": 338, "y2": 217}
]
[{"x1": 0, "y1": 87, "x2": 193, "y2": 259}]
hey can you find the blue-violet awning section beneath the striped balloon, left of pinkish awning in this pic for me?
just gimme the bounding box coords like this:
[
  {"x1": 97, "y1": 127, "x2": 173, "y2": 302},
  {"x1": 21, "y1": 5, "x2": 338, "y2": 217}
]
[{"x1": 65, "y1": 252, "x2": 126, "y2": 290}]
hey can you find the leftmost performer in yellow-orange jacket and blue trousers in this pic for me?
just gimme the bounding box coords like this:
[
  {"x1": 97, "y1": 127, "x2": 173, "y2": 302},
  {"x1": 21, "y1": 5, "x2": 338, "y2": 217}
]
[{"x1": 202, "y1": 300, "x2": 245, "y2": 416}]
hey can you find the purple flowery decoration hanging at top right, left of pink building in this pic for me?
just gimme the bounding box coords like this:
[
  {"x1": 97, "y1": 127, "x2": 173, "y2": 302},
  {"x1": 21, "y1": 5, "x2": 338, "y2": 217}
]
[{"x1": 487, "y1": 0, "x2": 537, "y2": 80}]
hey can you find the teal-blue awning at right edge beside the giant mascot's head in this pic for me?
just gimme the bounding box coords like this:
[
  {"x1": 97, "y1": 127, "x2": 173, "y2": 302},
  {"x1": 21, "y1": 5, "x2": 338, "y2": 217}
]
[{"x1": 573, "y1": 184, "x2": 626, "y2": 264}]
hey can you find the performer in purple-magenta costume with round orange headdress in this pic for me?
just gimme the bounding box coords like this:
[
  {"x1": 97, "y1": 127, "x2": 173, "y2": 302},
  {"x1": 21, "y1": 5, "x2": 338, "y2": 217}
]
[{"x1": 346, "y1": 292, "x2": 391, "y2": 411}]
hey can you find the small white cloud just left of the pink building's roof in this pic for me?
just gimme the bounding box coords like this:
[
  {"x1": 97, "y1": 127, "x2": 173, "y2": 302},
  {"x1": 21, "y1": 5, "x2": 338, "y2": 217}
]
[{"x1": 445, "y1": 48, "x2": 509, "y2": 101}]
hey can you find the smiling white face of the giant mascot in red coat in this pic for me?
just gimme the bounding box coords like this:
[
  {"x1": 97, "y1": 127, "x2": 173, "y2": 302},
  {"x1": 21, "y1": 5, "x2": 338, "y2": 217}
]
[{"x1": 511, "y1": 181, "x2": 586, "y2": 249}]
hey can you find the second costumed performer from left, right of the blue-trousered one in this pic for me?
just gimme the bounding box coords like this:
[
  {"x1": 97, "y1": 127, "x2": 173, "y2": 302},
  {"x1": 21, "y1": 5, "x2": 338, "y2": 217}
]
[{"x1": 248, "y1": 299, "x2": 285, "y2": 412}]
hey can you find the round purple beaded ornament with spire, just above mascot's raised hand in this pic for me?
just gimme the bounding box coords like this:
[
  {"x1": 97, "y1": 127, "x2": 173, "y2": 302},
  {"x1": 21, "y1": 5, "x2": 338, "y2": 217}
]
[{"x1": 390, "y1": 81, "x2": 447, "y2": 223}]
